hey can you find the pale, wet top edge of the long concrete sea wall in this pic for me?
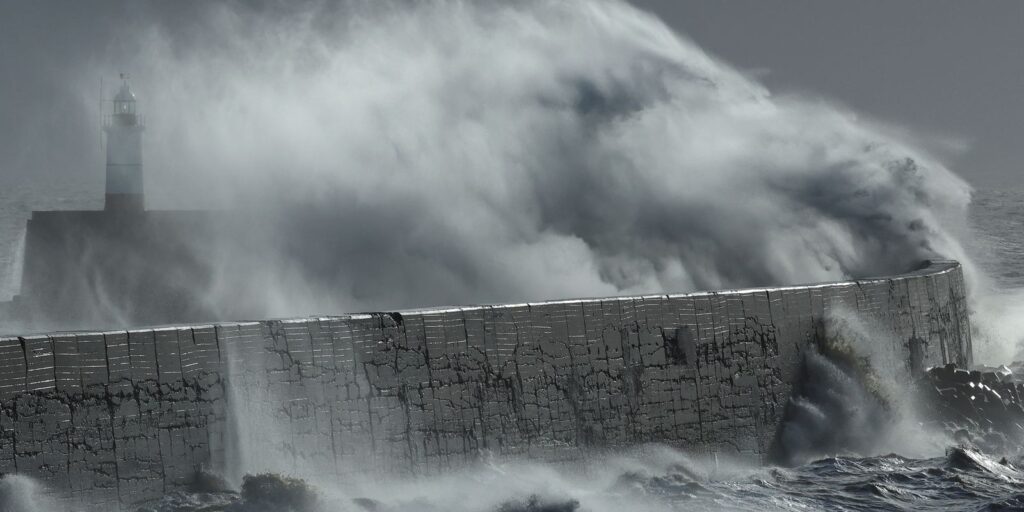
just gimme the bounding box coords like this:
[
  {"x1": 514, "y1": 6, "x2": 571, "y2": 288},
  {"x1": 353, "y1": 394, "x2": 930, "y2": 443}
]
[{"x1": 0, "y1": 259, "x2": 961, "y2": 337}]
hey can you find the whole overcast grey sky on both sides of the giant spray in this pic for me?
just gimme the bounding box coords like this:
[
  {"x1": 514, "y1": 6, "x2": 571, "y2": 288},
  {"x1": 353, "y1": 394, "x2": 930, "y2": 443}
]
[{"x1": 0, "y1": 0, "x2": 1024, "y2": 186}]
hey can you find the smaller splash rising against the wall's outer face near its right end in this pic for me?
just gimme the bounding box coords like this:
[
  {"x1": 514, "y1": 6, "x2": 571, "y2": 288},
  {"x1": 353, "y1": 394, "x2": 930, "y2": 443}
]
[{"x1": 771, "y1": 306, "x2": 950, "y2": 466}]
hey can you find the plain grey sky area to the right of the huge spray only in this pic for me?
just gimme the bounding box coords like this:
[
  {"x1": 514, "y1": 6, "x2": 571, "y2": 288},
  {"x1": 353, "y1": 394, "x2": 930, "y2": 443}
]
[{"x1": 632, "y1": 0, "x2": 1024, "y2": 186}]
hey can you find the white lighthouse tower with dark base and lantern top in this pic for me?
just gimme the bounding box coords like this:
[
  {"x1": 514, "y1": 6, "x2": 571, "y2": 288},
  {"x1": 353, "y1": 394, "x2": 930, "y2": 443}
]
[{"x1": 103, "y1": 74, "x2": 145, "y2": 211}]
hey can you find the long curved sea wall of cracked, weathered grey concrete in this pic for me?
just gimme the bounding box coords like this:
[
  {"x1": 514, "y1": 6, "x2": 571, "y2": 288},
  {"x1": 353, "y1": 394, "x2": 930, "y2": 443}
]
[{"x1": 0, "y1": 262, "x2": 971, "y2": 510}]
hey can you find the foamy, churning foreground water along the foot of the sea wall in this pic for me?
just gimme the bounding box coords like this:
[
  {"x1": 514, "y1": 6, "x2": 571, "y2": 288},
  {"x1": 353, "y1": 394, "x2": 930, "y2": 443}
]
[{"x1": 134, "y1": 447, "x2": 1024, "y2": 512}]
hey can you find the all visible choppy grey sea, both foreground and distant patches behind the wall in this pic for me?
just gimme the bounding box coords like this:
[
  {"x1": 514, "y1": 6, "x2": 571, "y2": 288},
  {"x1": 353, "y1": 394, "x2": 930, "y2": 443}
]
[{"x1": 0, "y1": 187, "x2": 1024, "y2": 512}]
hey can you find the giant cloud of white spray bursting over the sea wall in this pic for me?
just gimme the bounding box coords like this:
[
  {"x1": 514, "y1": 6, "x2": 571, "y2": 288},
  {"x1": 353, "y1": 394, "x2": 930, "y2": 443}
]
[{"x1": 56, "y1": 0, "x2": 970, "y2": 325}]
